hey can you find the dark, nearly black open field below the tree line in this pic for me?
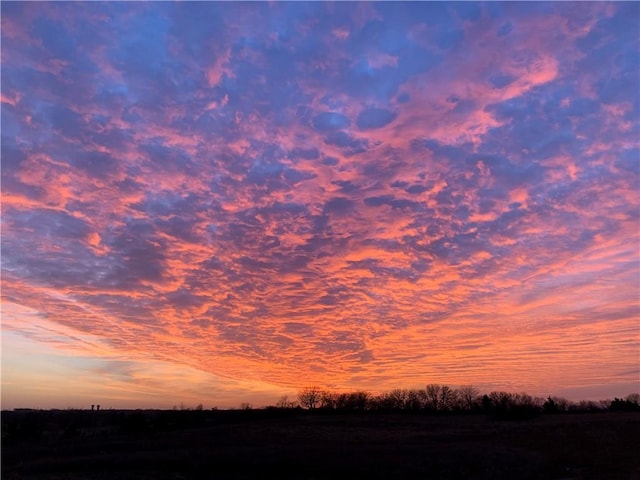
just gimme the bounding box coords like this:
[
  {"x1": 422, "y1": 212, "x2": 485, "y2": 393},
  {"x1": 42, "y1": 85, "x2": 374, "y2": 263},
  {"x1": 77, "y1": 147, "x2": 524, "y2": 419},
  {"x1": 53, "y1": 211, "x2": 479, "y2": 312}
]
[{"x1": 2, "y1": 410, "x2": 640, "y2": 480}]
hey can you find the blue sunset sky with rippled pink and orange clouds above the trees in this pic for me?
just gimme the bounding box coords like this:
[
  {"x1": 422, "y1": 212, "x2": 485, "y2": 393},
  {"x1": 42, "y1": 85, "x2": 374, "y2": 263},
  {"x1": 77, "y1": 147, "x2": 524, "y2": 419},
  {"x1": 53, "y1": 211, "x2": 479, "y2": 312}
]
[{"x1": 0, "y1": 2, "x2": 640, "y2": 409}]
